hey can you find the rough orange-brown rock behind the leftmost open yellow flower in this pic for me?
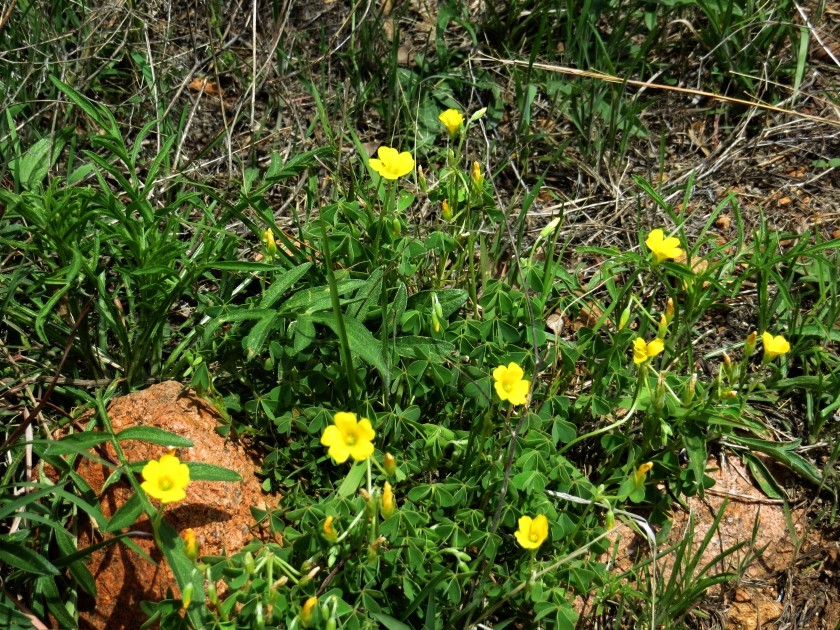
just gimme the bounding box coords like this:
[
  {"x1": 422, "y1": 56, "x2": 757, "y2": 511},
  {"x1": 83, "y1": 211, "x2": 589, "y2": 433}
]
[{"x1": 72, "y1": 382, "x2": 265, "y2": 630}]
